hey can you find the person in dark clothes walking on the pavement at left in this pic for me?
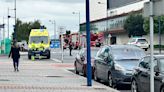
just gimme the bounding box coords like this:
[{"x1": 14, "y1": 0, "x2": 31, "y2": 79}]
[{"x1": 9, "y1": 42, "x2": 20, "y2": 72}]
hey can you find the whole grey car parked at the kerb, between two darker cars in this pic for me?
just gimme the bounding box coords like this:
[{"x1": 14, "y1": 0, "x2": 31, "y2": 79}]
[{"x1": 94, "y1": 45, "x2": 145, "y2": 87}]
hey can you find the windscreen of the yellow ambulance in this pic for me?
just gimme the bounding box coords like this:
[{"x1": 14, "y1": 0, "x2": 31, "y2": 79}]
[{"x1": 30, "y1": 36, "x2": 48, "y2": 44}]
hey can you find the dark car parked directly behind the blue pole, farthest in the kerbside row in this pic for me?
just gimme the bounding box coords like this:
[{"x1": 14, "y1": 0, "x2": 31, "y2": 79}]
[{"x1": 74, "y1": 48, "x2": 99, "y2": 76}]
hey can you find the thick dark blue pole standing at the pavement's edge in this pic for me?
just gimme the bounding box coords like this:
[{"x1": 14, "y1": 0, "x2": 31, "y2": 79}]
[{"x1": 86, "y1": 0, "x2": 92, "y2": 86}]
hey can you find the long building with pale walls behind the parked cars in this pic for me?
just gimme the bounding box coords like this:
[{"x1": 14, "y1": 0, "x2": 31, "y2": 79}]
[{"x1": 80, "y1": 0, "x2": 158, "y2": 44}]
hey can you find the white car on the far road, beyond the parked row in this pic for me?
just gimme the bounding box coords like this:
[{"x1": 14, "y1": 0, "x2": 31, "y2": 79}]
[{"x1": 128, "y1": 38, "x2": 149, "y2": 51}]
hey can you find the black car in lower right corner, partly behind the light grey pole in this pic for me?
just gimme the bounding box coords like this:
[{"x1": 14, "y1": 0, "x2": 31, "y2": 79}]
[{"x1": 131, "y1": 55, "x2": 164, "y2": 92}]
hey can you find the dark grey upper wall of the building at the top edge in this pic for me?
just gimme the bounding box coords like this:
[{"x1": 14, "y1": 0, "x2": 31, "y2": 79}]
[{"x1": 107, "y1": 0, "x2": 140, "y2": 9}]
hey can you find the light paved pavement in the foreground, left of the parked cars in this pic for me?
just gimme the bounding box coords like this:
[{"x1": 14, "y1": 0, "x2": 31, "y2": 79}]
[{"x1": 0, "y1": 54, "x2": 118, "y2": 92}]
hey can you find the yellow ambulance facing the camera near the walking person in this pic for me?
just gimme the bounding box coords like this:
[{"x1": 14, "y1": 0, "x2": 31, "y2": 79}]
[{"x1": 28, "y1": 29, "x2": 51, "y2": 59}]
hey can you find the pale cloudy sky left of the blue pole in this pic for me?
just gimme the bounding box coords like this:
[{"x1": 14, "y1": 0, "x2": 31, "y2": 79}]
[{"x1": 0, "y1": 0, "x2": 85, "y2": 37}]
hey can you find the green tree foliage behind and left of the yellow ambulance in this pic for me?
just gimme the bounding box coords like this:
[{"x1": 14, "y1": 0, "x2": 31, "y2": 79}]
[{"x1": 16, "y1": 19, "x2": 45, "y2": 41}]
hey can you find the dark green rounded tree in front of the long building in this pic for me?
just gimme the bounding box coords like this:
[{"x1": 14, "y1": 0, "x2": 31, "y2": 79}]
[{"x1": 124, "y1": 14, "x2": 146, "y2": 37}]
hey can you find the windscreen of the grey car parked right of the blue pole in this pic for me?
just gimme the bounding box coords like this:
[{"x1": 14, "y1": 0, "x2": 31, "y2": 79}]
[{"x1": 112, "y1": 48, "x2": 145, "y2": 60}]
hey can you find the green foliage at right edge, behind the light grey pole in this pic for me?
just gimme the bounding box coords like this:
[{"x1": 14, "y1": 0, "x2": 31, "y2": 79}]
[{"x1": 144, "y1": 16, "x2": 164, "y2": 33}]
